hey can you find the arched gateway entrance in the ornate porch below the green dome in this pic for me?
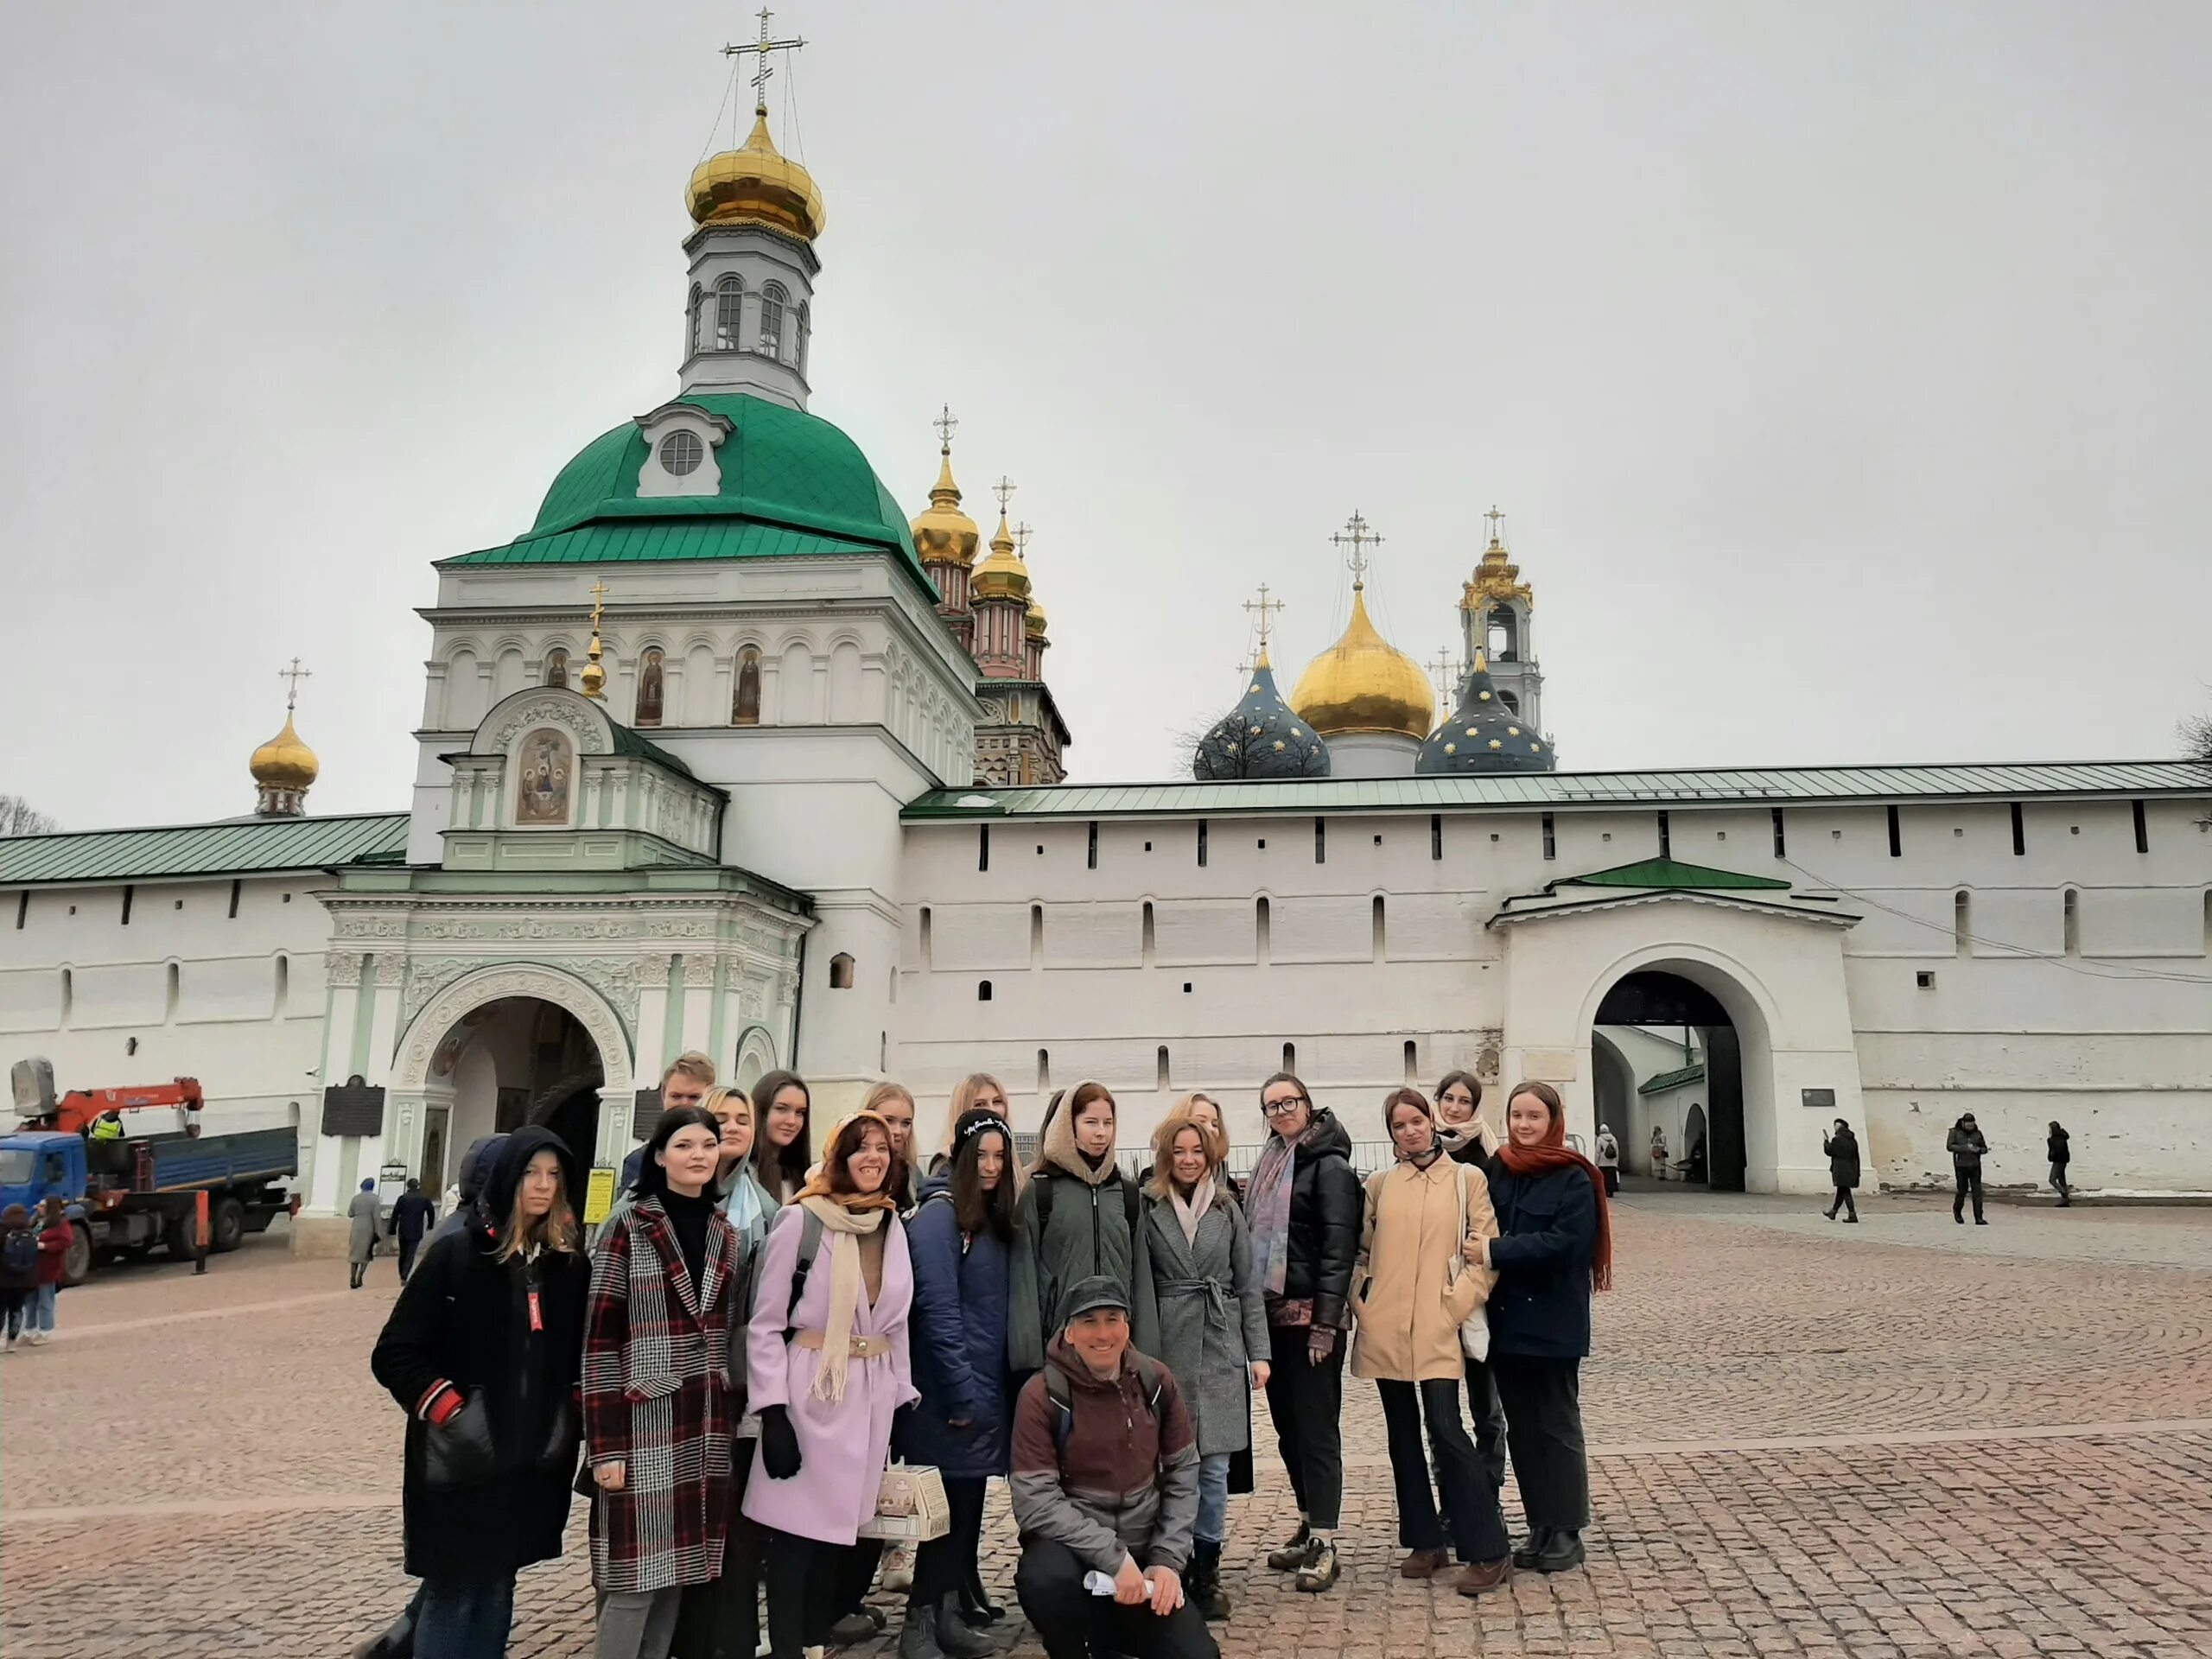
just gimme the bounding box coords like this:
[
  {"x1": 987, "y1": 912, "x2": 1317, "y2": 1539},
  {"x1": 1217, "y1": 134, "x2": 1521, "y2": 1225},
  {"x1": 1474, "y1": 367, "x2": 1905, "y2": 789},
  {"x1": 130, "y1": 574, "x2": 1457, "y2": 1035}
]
[{"x1": 394, "y1": 967, "x2": 631, "y2": 1208}]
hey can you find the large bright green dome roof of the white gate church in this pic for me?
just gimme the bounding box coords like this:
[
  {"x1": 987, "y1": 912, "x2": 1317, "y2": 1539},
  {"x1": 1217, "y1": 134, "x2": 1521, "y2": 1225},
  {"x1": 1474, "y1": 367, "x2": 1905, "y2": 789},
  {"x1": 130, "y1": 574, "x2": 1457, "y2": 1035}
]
[{"x1": 445, "y1": 391, "x2": 936, "y2": 597}]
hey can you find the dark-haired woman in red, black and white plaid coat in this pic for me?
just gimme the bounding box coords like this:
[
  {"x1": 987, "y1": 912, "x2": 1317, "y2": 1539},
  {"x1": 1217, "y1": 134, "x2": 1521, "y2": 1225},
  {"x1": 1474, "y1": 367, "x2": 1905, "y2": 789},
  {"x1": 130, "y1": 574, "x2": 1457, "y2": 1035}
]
[{"x1": 584, "y1": 1106, "x2": 741, "y2": 1659}]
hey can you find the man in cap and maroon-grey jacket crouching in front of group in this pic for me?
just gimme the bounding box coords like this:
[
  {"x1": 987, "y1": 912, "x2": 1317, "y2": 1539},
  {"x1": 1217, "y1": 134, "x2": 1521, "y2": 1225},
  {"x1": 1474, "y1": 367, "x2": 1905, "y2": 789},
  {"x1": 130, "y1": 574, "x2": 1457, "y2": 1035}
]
[{"x1": 1011, "y1": 1276, "x2": 1221, "y2": 1659}]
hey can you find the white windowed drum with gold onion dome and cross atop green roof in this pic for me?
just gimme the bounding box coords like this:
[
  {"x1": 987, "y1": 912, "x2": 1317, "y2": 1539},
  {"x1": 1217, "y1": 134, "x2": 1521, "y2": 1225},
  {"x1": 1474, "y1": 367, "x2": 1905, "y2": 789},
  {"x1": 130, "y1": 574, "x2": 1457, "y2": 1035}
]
[{"x1": 679, "y1": 9, "x2": 825, "y2": 410}]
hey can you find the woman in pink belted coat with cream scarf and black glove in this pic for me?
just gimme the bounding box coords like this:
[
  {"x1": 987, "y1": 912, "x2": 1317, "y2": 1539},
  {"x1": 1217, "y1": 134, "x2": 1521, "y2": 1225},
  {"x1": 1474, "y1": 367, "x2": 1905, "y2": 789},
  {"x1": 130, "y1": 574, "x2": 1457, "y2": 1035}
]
[{"x1": 746, "y1": 1113, "x2": 920, "y2": 1659}]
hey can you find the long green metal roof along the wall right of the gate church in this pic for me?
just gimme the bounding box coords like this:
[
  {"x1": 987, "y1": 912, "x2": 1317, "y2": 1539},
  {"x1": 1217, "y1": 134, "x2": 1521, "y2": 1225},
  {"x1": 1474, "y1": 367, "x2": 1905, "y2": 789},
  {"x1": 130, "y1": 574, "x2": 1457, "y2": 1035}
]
[{"x1": 905, "y1": 761, "x2": 2212, "y2": 823}]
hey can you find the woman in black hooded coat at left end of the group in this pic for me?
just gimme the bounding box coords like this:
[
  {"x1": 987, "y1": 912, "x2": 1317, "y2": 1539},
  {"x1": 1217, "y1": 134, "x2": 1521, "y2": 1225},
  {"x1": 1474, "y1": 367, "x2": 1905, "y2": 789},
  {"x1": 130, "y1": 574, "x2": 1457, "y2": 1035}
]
[{"x1": 370, "y1": 1123, "x2": 591, "y2": 1659}]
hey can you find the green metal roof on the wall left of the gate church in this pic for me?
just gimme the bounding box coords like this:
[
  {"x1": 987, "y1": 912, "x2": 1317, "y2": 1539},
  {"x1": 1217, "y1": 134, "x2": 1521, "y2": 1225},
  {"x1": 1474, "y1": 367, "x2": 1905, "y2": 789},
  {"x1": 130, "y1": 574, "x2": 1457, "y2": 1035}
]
[{"x1": 0, "y1": 812, "x2": 407, "y2": 887}]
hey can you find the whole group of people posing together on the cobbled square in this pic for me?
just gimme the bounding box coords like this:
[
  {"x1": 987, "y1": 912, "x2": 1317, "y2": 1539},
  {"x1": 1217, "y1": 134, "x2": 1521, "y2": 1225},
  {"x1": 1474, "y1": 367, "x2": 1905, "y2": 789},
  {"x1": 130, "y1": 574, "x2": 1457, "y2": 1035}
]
[{"x1": 360, "y1": 1055, "x2": 1611, "y2": 1659}]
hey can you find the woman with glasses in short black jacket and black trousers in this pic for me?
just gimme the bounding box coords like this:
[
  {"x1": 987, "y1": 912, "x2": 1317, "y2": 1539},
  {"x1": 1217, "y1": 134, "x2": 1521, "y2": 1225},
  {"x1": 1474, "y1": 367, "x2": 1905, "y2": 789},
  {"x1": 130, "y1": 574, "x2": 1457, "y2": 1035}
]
[{"x1": 1248, "y1": 1071, "x2": 1360, "y2": 1592}]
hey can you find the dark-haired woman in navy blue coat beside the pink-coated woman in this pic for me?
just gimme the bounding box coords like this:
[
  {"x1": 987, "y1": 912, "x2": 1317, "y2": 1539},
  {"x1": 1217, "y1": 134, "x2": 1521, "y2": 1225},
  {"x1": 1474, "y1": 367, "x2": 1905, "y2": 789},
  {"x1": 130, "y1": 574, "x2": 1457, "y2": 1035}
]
[{"x1": 898, "y1": 1109, "x2": 1015, "y2": 1659}]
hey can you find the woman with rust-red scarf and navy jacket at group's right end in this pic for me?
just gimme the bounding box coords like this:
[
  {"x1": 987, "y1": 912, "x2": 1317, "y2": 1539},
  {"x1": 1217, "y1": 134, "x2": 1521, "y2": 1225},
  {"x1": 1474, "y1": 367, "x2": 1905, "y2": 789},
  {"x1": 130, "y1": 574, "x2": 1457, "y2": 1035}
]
[{"x1": 1466, "y1": 1082, "x2": 1612, "y2": 1573}]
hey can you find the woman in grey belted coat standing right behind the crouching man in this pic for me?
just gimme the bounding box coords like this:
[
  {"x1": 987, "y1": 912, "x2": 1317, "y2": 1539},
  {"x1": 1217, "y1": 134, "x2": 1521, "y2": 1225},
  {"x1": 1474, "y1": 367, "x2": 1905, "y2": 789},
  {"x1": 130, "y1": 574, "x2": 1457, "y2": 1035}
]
[{"x1": 1135, "y1": 1109, "x2": 1268, "y2": 1619}]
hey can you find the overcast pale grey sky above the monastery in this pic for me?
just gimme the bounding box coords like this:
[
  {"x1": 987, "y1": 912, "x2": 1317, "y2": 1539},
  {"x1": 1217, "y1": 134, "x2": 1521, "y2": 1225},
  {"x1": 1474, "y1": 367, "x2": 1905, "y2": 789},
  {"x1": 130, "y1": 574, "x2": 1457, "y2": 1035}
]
[{"x1": 0, "y1": 0, "x2": 2212, "y2": 827}]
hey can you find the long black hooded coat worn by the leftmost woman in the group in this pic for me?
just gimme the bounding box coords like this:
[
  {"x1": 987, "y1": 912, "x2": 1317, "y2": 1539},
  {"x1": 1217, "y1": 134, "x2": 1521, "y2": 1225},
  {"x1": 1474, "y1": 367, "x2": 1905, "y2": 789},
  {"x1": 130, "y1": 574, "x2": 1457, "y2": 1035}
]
[{"x1": 370, "y1": 1126, "x2": 591, "y2": 1580}]
